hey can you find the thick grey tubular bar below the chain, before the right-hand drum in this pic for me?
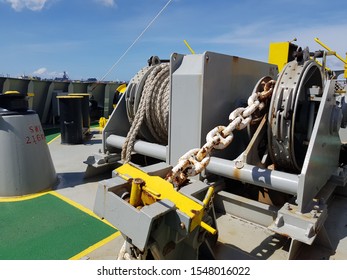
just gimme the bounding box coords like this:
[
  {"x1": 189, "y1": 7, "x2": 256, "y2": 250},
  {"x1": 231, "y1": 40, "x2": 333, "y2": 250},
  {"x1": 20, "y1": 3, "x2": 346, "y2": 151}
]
[{"x1": 206, "y1": 157, "x2": 299, "y2": 195}]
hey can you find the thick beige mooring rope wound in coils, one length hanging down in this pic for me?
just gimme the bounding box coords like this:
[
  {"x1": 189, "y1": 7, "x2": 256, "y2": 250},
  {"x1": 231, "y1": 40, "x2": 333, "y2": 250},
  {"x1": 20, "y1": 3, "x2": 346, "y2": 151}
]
[{"x1": 122, "y1": 63, "x2": 170, "y2": 163}]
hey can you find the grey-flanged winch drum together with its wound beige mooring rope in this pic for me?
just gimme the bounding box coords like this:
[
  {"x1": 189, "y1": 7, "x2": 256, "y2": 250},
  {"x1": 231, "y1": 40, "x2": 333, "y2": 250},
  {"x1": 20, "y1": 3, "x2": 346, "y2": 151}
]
[{"x1": 122, "y1": 63, "x2": 170, "y2": 163}]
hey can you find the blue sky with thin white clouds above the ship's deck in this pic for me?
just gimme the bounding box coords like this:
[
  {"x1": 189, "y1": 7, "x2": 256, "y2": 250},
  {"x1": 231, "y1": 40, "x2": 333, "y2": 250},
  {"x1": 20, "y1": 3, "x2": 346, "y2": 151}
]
[{"x1": 0, "y1": 0, "x2": 347, "y2": 80}]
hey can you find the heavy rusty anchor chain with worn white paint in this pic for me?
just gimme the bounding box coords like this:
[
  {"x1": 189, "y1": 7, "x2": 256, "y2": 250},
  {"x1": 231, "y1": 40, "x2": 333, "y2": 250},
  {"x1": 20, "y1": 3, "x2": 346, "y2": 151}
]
[{"x1": 166, "y1": 77, "x2": 276, "y2": 189}]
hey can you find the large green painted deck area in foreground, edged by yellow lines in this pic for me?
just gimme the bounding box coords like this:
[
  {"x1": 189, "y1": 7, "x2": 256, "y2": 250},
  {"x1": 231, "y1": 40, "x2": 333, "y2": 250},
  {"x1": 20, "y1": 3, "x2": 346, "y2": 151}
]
[{"x1": 0, "y1": 194, "x2": 117, "y2": 260}]
